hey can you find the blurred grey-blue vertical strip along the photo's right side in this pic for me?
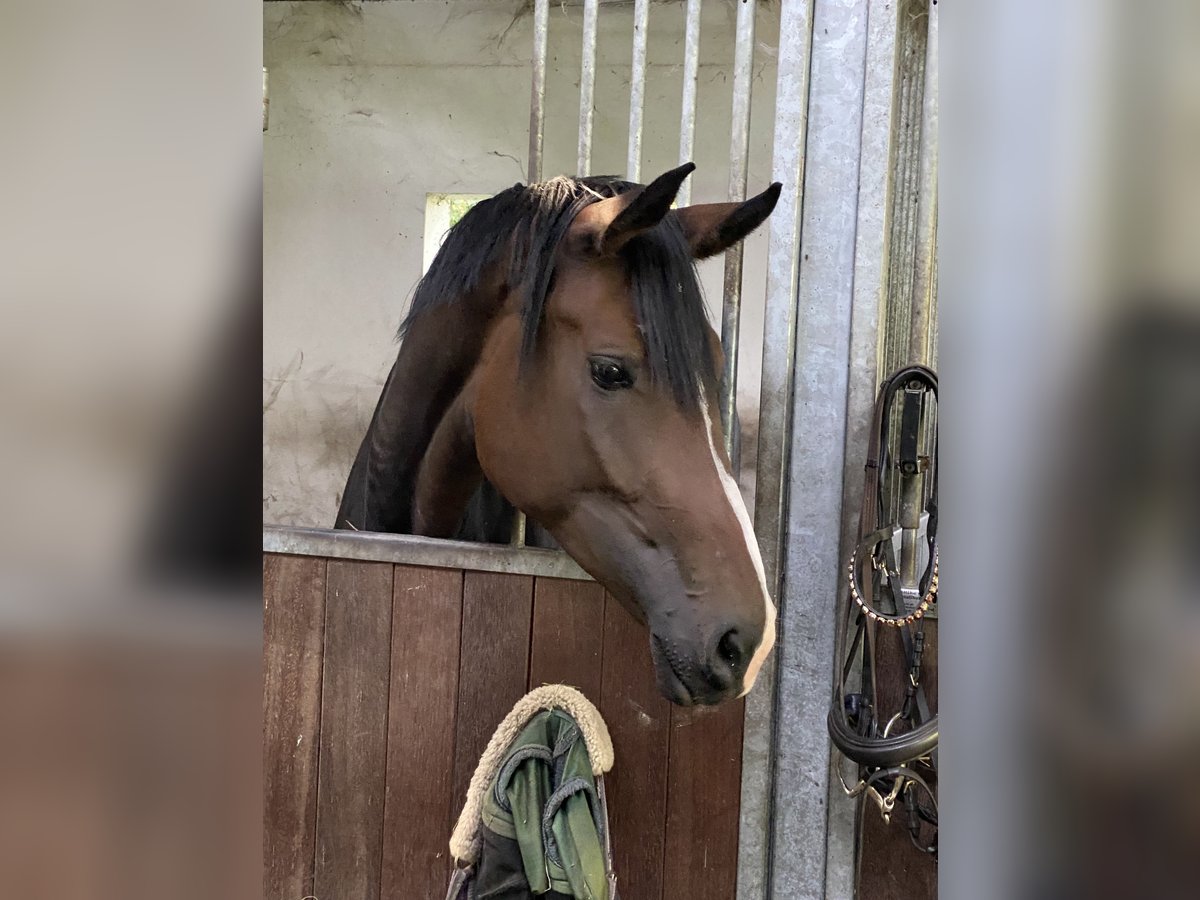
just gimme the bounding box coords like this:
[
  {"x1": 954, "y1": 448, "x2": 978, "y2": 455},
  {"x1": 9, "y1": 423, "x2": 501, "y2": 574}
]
[{"x1": 940, "y1": 0, "x2": 1200, "y2": 898}]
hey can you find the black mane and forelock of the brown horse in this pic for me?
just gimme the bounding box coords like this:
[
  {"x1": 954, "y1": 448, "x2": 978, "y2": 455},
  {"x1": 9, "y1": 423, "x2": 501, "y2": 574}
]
[{"x1": 400, "y1": 176, "x2": 714, "y2": 408}]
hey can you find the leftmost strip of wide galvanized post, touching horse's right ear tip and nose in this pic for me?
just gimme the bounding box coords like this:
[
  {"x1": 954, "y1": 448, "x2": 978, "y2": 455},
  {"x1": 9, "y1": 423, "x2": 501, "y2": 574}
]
[{"x1": 737, "y1": 0, "x2": 824, "y2": 900}]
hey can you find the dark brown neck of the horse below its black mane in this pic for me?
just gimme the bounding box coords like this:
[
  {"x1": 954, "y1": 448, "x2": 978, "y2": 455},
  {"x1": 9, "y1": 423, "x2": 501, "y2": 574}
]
[{"x1": 338, "y1": 288, "x2": 503, "y2": 533}]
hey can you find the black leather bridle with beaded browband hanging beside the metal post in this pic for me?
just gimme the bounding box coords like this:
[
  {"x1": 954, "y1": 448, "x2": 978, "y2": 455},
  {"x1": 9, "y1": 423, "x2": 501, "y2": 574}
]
[{"x1": 828, "y1": 366, "x2": 938, "y2": 857}]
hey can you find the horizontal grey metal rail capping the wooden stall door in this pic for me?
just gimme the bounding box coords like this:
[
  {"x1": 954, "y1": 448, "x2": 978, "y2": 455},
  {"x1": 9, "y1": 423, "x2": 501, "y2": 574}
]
[{"x1": 263, "y1": 526, "x2": 592, "y2": 581}]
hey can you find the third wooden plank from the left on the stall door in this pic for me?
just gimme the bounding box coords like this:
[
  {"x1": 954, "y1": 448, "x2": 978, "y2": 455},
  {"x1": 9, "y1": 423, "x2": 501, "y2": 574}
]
[{"x1": 380, "y1": 565, "x2": 462, "y2": 898}]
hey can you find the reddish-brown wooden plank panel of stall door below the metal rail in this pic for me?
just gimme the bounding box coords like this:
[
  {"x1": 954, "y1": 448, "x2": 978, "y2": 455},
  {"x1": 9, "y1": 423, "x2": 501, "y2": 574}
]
[{"x1": 263, "y1": 554, "x2": 743, "y2": 900}]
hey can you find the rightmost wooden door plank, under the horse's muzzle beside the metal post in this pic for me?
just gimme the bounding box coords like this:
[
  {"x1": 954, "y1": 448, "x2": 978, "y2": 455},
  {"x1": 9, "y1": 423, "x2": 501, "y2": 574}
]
[{"x1": 662, "y1": 700, "x2": 745, "y2": 900}]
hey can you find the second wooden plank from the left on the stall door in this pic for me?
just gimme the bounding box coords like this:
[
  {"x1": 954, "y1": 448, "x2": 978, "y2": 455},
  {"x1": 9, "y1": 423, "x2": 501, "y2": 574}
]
[{"x1": 312, "y1": 559, "x2": 394, "y2": 900}]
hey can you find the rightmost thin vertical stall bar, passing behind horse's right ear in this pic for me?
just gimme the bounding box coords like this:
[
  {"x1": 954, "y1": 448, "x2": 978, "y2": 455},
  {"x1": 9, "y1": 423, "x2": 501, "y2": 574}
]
[{"x1": 721, "y1": 0, "x2": 757, "y2": 451}]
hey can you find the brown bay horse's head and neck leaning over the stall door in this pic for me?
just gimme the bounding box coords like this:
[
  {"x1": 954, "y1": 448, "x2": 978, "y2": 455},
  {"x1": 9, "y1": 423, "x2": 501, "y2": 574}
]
[{"x1": 336, "y1": 163, "x2": 780, "y2": 706}]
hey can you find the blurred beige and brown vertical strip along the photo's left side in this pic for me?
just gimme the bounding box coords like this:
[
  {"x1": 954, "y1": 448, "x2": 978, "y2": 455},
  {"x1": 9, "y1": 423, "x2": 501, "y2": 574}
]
[{"x1": 0, "y1": 0, "x2": 262, "y2": 900}]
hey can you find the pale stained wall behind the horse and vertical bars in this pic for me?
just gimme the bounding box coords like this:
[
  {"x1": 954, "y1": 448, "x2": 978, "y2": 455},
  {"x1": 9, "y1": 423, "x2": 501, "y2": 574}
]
[{"x1": 263, "y1": 0, "x2": 779, "y2": 526}]
